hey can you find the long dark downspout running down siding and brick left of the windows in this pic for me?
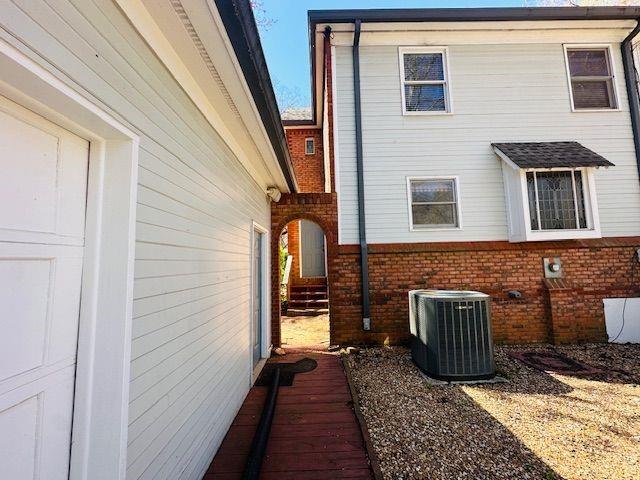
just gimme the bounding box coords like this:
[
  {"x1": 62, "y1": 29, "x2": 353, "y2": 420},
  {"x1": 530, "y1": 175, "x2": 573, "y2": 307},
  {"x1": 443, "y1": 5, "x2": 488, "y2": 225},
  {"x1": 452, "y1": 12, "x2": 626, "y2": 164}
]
[{"x1": 353, "y1": 19, "x2": 371, "y2": 330}]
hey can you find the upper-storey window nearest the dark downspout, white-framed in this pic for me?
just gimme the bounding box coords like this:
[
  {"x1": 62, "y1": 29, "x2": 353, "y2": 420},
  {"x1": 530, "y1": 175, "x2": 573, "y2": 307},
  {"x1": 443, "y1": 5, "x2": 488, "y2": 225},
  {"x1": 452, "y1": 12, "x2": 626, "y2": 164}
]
[{"x1": 399, "y1": 47, "x2": 451, "y2": 115}]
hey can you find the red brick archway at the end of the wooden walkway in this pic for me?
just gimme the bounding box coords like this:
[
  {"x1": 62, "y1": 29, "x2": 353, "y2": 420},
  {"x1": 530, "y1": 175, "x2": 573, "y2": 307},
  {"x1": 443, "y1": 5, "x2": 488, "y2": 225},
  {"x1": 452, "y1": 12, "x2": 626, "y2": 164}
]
[{"x1": 271, "y1": 193, "x2": 338, "y2": 347}]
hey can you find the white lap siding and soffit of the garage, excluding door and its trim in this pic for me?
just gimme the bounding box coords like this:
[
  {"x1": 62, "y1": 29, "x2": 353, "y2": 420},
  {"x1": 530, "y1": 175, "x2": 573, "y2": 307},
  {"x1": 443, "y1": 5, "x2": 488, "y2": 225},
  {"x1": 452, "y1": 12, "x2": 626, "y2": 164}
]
[{"x1": 0, "y1": 0, "x2": 269, "y2": 479}]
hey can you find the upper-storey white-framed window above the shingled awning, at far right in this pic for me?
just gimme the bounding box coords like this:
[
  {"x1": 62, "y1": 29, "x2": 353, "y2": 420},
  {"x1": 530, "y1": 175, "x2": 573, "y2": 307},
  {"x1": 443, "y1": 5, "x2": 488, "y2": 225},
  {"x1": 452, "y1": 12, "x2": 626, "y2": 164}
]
[{"x1": 566, "y1": 46, "x2": 618, "y2": 110}]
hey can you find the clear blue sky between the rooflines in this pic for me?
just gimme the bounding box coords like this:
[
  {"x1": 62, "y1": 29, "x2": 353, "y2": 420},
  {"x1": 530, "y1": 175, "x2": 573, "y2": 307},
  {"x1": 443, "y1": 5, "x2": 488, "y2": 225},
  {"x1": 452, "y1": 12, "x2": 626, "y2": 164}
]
[{"x1": 257, "y1": 0, "x2": 535, "y2": 109}]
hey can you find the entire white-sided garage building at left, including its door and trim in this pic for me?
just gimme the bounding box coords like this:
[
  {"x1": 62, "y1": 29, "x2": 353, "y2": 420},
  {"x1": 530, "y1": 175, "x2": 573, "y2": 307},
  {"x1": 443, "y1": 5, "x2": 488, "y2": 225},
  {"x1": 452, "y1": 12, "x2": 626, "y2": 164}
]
[{"x1": 0, "y1": 0, "x2": 295, "y2": 480}]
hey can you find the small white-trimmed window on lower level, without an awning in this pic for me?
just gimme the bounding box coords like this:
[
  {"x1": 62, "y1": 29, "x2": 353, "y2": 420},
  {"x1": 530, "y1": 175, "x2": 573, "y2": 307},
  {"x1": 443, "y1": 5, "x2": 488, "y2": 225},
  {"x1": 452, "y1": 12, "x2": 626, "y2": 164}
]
[{"x1": 407, "y1": 178, "x2": 460, "y2": 229}]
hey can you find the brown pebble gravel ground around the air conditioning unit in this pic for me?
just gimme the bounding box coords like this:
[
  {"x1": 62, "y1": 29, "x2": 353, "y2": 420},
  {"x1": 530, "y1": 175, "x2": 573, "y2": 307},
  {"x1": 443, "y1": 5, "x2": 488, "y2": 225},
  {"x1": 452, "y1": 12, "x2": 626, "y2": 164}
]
[{"x1": 347, "y1": 345, "x2": 640, "y2": 480}]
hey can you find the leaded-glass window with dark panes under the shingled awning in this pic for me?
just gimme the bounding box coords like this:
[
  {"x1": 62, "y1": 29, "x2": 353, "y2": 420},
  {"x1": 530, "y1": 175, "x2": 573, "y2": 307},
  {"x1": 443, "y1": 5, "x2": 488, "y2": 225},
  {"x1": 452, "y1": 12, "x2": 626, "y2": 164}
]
[{"x1": 527, "y1": 170, "x2": 587, "y2": 230}]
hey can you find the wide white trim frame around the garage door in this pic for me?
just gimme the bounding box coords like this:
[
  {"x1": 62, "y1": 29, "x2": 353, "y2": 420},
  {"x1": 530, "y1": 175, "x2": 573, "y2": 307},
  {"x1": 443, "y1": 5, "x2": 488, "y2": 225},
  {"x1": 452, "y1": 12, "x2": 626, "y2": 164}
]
[{"x1": 0, "y1": 40, "x2": 139, "y2": 480}]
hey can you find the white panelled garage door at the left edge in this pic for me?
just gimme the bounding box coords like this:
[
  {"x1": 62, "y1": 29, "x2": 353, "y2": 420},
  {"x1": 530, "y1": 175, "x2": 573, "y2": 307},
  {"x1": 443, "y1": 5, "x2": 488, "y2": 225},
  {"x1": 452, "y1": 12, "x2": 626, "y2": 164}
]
[{"x1": 0, "y1": 97, "x2": 89, "y2": 480}]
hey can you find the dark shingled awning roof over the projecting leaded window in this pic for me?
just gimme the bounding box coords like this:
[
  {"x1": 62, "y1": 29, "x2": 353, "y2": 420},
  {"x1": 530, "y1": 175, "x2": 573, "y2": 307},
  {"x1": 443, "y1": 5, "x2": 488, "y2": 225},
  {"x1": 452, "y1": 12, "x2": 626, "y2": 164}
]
[{"x1": 491, "y1": 142, "x2": 614, "y2": 168}]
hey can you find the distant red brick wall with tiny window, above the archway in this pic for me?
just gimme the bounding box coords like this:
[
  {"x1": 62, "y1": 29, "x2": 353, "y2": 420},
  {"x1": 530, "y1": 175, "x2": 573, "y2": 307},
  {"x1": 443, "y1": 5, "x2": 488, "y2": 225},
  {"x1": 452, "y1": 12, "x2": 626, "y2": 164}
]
[{"x1": 285, "y1": 127, "x2": 324, "y2": 193}]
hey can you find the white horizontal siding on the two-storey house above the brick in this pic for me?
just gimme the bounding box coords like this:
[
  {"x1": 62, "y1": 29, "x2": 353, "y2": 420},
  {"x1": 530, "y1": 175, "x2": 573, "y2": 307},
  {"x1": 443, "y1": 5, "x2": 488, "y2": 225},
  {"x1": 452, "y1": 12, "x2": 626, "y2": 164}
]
[{"x1": 335, "y1": 42, "x2": 640, "y2": 244}]
